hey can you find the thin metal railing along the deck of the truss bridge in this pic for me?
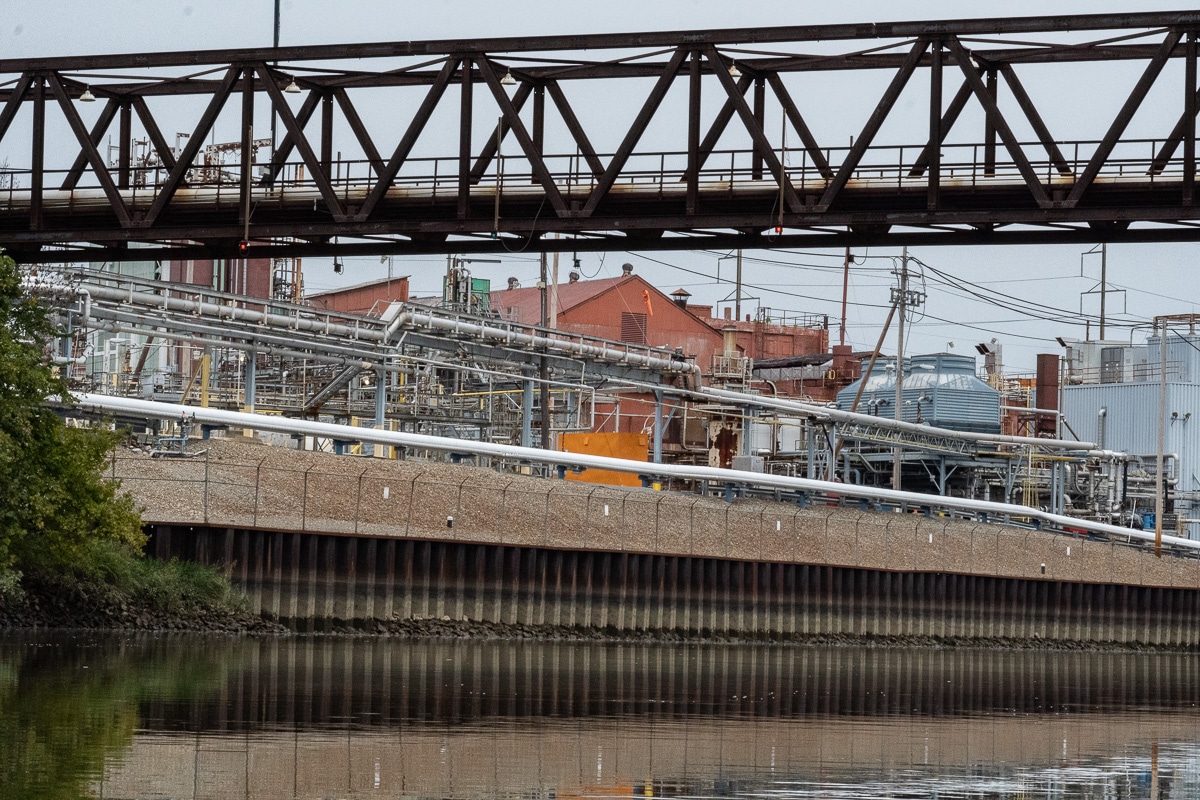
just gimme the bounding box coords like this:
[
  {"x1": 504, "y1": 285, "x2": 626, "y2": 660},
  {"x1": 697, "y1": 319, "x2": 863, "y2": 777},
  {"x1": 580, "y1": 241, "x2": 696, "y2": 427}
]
[{"x1": 0, "y1": 139, "x2": 1182, "y2": 210}]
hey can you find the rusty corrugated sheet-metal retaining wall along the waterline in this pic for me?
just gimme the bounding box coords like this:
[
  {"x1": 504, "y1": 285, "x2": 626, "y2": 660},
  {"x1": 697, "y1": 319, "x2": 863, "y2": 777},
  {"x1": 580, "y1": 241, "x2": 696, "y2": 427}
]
[{"x1": 149, "y1": 525, "x2": 1200, "y2": 646}]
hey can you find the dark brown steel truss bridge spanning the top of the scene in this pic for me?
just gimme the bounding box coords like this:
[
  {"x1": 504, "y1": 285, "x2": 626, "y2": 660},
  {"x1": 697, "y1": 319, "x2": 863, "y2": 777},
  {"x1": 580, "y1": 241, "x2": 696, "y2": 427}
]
[{"x1": 0, "y1": 11, "x2": 1200, "y2": 261}]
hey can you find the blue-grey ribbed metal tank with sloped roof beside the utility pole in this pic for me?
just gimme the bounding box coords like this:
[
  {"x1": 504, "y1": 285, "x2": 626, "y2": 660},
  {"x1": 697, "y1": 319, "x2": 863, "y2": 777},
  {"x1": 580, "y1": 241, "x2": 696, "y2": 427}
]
[{"x1": 838, "y1": 353, "x2": 1000, "y2": 433}]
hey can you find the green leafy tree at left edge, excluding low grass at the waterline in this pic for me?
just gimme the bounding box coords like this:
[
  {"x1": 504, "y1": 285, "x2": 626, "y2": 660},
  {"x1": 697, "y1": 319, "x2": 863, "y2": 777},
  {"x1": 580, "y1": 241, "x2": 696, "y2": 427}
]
[{"x1": 0, "y1": 255, "x2": 144, "y2": 577}]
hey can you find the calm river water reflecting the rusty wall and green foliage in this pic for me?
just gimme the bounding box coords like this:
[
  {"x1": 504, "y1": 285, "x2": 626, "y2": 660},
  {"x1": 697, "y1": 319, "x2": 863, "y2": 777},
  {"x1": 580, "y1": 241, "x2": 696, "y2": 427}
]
[{"x1": 0, "y1": 633, "x2": 1200, "y2": 800}]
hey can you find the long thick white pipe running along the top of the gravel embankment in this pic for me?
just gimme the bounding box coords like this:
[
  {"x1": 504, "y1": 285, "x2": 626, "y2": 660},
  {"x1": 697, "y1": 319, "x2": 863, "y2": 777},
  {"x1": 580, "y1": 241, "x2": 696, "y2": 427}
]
[{"x1": 78, "y1": 395, "x2": 1200, "y2": 554}]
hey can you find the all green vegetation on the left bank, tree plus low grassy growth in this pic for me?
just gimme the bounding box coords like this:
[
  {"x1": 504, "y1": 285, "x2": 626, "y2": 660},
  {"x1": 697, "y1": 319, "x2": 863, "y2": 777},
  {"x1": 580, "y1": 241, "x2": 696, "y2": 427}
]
[{"x1": 0, "y1": 254, "x2": 240, "y2": 614}]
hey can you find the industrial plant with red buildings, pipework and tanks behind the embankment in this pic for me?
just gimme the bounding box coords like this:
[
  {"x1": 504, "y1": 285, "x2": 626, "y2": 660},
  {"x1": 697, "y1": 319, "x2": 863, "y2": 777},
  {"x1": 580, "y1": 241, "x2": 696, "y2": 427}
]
[{"x1": 32, "y1": 250, "x2": 1200, "y2": 537}]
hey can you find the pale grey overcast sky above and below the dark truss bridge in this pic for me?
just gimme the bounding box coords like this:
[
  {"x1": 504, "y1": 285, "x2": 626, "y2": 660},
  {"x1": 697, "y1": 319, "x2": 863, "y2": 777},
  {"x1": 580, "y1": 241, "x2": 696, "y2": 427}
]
[{"x1": 7, "y1": 0, "x2": 1200, "y2": 371}]
